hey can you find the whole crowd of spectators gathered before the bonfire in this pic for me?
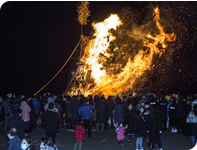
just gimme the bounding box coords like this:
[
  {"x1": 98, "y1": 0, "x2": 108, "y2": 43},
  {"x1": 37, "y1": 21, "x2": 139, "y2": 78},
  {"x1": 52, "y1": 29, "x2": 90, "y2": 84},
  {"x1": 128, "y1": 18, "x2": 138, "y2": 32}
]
[{"x1": 0, "y1": 89, "x2": 197, "y2": 150}]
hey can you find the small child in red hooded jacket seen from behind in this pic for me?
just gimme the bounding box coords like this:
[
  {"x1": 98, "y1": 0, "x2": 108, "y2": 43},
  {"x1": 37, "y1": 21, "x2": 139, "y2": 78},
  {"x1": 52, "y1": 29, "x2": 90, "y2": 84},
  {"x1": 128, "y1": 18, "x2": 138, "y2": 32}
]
[{"x1": 73, "y1": 122, "x2": 86, "y2": 150}]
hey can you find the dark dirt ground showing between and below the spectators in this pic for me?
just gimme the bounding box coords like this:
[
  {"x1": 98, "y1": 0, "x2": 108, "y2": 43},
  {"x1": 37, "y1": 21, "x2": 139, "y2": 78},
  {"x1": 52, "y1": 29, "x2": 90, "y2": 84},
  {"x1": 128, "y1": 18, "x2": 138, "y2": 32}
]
[{"x1": 0, "y1": 125, "x2": 195, "y2": 150}]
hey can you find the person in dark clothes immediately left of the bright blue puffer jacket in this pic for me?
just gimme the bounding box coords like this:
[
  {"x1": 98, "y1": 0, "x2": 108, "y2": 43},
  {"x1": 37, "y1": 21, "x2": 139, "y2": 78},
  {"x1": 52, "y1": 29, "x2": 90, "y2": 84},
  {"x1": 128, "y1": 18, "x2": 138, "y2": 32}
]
[{"x1": 69, "y1": 96, "x2": 79, "y2": 132}]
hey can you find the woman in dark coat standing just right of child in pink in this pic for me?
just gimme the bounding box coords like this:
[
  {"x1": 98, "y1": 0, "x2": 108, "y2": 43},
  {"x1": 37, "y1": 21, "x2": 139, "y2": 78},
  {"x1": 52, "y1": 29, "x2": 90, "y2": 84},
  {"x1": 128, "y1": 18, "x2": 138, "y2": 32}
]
[{"x1": 125, "y1": 102, "x2": 136, "y2": 143}]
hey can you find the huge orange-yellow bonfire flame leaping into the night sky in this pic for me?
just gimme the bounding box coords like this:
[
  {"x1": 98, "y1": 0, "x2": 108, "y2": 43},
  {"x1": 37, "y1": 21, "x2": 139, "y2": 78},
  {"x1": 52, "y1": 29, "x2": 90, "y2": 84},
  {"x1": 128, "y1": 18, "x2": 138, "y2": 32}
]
[{"x1": 70, "y1": 8, "x2": 176, "y2": 96}]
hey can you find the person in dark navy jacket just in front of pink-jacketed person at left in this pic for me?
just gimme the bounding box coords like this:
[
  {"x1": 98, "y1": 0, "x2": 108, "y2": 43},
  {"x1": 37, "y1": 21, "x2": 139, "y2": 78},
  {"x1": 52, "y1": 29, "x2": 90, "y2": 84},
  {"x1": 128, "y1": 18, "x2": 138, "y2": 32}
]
[{"x1": 7, "y1": 109, "x2": 29, "y2": 139}]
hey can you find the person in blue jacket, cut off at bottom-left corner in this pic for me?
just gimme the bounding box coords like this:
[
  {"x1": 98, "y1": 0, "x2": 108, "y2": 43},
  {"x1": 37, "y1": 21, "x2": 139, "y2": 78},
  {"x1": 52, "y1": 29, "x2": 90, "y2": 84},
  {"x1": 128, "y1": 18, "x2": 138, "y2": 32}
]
[{"x1": 7, "y1": 128, "x2": 22, "y2": 150}]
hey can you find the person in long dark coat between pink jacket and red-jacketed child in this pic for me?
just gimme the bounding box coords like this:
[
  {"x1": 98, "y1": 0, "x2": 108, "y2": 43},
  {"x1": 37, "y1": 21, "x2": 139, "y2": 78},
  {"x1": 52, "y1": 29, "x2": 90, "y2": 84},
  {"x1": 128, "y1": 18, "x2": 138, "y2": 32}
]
[{"x1": 44, "y1": 103, "x2": 59, "y2": 144}]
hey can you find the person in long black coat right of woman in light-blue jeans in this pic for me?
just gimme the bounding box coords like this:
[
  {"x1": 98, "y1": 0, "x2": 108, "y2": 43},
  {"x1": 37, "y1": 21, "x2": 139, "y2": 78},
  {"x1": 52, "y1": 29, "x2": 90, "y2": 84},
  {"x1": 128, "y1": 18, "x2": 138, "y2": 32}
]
[{"x1": 147, "y1": 107, "x2": 163, "y2": 149}]
